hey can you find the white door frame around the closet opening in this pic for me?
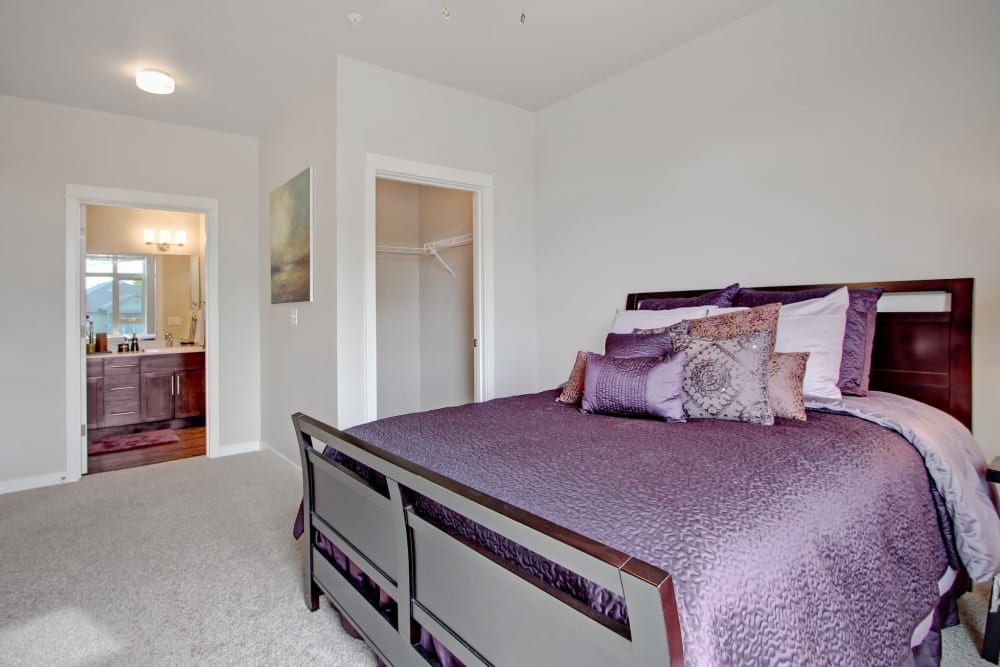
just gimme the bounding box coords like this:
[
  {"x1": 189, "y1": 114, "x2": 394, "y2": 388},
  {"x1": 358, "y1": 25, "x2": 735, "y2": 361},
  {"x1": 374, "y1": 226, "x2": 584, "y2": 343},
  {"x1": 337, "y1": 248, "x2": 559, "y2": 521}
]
[{"x1": 363, "y1": 153, "x2": 496, "y2": 421}]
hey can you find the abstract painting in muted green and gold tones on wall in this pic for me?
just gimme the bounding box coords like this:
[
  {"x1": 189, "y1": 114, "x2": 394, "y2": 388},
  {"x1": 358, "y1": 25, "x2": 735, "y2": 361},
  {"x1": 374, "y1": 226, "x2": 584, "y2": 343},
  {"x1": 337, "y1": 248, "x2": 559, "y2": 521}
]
[{"x1": 271, "y1": 169, "x2": 312, "y2": 303}]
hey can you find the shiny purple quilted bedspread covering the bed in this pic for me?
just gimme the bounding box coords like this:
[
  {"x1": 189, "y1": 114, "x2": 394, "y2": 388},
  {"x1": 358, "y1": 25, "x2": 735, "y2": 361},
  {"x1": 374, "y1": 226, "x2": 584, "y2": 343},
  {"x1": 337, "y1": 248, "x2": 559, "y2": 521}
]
[{"x1": 349, "y1": 391, "x2": 948, "y2": 665}]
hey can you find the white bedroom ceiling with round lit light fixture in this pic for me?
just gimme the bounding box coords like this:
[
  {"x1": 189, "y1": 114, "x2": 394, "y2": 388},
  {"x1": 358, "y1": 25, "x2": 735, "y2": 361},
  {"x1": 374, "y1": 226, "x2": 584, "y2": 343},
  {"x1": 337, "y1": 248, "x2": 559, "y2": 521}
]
[{"x1": 0, "y1": 0, "x2": 773, "y2": 135}]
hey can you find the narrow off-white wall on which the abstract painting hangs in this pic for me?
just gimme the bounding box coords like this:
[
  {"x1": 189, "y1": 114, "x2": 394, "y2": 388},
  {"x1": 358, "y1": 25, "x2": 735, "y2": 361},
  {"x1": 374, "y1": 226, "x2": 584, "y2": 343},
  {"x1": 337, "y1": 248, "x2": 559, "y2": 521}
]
[{"x1": 256, "y1": 68, "x2": 338, "y2": 464}]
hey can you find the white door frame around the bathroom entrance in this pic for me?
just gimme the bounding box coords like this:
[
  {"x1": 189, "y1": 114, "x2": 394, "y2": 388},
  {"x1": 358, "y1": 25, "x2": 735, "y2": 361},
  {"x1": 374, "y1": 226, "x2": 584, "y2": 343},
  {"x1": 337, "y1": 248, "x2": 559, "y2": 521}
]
[{"x1": 65, "y1": 184, "x2": 221, "y2": 482}]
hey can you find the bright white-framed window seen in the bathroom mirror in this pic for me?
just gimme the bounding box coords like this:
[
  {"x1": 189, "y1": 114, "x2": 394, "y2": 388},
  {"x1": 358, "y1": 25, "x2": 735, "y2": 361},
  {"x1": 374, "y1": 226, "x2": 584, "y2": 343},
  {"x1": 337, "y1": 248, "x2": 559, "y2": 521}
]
[{"x1": 86, "y1": 255, "x2": 153, "y2": 336}]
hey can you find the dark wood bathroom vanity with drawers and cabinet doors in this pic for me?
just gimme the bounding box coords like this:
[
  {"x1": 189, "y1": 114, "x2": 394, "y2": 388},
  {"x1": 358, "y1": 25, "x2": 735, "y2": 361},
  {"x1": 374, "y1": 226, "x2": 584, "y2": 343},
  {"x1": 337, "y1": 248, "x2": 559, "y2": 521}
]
[{"x1": 87, "y1": 347, "x2": 205, "y2": 439}]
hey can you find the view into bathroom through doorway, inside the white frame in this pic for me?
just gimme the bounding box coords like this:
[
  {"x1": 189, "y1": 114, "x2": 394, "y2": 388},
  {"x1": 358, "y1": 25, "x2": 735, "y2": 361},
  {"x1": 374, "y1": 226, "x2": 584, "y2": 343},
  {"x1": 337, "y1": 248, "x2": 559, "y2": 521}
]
[{"x1": 81, "y1": 204, "x2": 206, "y2": 473}]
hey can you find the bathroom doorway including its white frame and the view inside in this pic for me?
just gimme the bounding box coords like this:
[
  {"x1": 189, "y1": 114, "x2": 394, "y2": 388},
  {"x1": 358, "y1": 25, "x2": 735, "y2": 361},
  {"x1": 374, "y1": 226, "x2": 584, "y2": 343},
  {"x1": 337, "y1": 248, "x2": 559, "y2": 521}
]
[{"x1": 66, "y1": 185, "x2": 219, "y2": 481}]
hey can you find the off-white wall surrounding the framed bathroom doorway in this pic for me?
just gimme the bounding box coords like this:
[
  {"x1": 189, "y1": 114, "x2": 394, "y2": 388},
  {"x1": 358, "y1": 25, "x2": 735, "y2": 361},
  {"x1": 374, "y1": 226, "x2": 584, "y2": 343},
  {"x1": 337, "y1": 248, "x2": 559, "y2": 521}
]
[{"x1": 0, "y1": 96, "x2": 260, "y2": 490}]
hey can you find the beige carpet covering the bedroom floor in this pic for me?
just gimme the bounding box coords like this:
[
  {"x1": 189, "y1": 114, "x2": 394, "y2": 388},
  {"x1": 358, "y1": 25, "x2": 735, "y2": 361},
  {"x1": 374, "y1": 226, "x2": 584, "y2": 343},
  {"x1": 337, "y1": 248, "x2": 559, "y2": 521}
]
[{"x1": 0, "y1": 452, "x2": 989, "y2": 667}]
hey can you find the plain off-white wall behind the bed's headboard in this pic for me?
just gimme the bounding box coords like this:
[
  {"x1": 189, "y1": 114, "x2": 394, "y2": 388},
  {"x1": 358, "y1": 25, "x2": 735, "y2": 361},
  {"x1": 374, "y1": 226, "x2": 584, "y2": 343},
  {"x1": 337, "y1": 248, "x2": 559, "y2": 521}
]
[{"x1": 538, "y1": 0, "x2": 1000, "y2": 454}]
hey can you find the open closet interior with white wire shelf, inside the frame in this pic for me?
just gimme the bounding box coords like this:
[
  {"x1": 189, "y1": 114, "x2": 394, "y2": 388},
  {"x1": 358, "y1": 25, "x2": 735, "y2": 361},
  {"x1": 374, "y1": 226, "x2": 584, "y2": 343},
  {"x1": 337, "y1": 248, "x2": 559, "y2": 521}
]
[{"x1": 375, "y1": 178, "x2": 478, "y2": 419}]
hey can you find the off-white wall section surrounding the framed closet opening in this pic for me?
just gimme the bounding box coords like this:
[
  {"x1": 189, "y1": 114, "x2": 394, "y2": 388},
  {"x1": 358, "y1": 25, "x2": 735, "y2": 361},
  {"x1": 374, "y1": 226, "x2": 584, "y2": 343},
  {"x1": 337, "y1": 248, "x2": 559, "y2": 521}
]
[{"x1": 336, "y1": 57, "x2": 538, "y2": 427}]
